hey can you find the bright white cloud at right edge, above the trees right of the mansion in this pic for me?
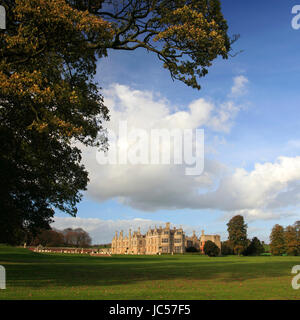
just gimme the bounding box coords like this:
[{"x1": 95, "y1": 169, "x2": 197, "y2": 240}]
[{"x1": 198, "y1": 157, "x2": 300, "y2": 219}]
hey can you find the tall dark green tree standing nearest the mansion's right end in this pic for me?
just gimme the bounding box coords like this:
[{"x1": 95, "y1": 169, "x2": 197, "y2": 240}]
[{"x1": 227, "y1": 215, "x2": 248, "y2": 255}]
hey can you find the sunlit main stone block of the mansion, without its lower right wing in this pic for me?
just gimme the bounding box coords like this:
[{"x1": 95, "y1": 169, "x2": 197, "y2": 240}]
[{"x1": 111, "y1": 223, "x2": 185, "y2": 254}]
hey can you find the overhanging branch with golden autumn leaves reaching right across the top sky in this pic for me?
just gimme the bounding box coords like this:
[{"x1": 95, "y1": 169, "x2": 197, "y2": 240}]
[{"x1": 83, "y1": 0, "x2": 237, "y2": 89}]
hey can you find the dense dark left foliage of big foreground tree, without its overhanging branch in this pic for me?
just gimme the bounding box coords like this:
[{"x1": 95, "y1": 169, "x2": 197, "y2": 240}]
[{"x1": 0, "y1": 0, "x2": 112, "y2": 244}]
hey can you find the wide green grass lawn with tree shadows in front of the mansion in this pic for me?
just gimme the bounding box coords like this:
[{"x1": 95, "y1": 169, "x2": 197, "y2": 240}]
[{"x1": 0, "y1": 245, "x2": 300, "y2": 300}]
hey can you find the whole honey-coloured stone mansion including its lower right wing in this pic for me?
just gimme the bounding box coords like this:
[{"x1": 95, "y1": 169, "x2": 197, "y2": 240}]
[{"x1": 111, "y1": 222, "x2": 221, "y2": 254}]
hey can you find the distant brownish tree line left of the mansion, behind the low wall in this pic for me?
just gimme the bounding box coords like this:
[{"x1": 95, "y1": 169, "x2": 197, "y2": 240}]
[{"x1": 27, "y1": 228, "x2": 92, "y2": 248}]
